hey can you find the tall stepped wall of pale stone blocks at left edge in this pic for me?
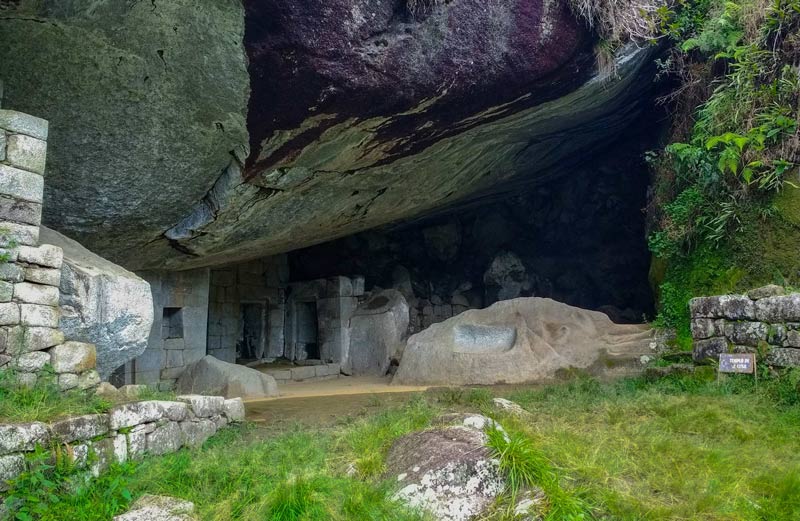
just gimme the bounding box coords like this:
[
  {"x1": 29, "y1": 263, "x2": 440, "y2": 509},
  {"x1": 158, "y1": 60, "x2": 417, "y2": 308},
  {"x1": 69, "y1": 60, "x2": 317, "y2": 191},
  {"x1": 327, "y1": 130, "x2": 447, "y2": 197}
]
[{"x1": 0, "y1": 102, "x2": 100, "y2": 390}]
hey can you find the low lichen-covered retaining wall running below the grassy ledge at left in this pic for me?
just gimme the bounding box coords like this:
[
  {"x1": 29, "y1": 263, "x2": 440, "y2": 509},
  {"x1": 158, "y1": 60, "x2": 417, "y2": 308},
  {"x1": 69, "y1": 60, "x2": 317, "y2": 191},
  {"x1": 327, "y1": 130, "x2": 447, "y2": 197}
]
[{"x1": 0, "y1": 395, "x2": 245, "y2": 492}]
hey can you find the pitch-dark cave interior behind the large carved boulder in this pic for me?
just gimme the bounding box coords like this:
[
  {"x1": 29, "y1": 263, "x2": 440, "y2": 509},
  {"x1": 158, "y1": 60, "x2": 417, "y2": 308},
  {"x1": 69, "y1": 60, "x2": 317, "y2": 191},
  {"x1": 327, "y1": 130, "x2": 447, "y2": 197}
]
[{"x1": 288, "y1": 120, "x2": 656, "y2": 328}]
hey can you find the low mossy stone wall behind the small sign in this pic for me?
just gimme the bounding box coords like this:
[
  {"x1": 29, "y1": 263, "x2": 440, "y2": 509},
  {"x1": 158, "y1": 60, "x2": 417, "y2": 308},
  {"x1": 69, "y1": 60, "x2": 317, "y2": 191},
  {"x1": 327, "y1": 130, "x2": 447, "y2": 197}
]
[{"x1": 689, "y1": 286, "x2": 800, "y2": 367}]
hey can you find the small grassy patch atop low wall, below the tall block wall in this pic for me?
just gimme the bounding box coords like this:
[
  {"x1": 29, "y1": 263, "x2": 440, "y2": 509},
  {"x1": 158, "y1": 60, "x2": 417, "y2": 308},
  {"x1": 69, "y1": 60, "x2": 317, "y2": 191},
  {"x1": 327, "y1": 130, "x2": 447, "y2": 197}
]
[{"x1": 0, "y1": 368, "x2": 112, "y2": 423}]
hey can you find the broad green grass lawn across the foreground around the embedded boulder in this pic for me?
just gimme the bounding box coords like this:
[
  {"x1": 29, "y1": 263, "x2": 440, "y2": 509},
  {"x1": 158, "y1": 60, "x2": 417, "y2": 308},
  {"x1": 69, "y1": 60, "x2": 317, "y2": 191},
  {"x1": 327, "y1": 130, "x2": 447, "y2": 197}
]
[{"x1": 7, "y1": 371, "x2": 800, "y2": 521}]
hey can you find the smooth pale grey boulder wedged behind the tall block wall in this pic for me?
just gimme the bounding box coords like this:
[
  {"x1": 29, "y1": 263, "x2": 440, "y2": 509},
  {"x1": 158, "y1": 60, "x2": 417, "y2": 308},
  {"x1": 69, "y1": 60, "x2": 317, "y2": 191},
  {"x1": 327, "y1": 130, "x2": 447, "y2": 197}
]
[{"x1": 39, "y1": 226, "x2": 153, "y2": 379}]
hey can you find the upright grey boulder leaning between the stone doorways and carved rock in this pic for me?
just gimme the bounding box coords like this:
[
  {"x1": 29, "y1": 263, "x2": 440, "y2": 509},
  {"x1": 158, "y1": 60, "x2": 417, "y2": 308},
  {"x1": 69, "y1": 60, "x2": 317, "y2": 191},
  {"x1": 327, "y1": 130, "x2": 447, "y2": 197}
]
[{"x1": 343, "y1": 289, "x2": 409, "y2": 376}]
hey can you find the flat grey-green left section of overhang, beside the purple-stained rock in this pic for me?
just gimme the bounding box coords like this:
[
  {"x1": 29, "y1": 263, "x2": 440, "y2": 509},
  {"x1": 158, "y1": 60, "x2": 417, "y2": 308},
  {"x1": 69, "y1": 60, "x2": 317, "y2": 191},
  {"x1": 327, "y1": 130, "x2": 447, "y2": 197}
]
[{"x1": 0, "y1": 0, "x2": 250, "y2": 269}]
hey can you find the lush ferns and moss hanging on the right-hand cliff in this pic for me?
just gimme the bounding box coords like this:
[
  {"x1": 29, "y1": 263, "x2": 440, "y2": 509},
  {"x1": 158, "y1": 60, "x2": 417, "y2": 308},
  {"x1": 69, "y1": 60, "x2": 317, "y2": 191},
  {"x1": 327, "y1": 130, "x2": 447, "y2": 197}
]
[{"x1": 650, "y1": 0, "x2": 800, "y2": 348}]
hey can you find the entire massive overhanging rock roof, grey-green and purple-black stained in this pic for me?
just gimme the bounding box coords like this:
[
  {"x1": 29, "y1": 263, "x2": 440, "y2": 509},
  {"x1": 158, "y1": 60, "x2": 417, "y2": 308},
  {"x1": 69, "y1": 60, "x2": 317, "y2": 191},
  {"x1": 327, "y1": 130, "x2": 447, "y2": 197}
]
[{"x1": 0, "y1": 0, "x2": 652, "y2": 269}]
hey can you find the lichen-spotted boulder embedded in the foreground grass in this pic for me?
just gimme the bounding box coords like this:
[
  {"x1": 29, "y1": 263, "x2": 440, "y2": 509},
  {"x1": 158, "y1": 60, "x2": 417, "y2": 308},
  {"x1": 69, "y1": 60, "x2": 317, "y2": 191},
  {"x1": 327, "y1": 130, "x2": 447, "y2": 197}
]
[{"x1": 386, "y1": 415, "x2": 505, "y2": 521}]
